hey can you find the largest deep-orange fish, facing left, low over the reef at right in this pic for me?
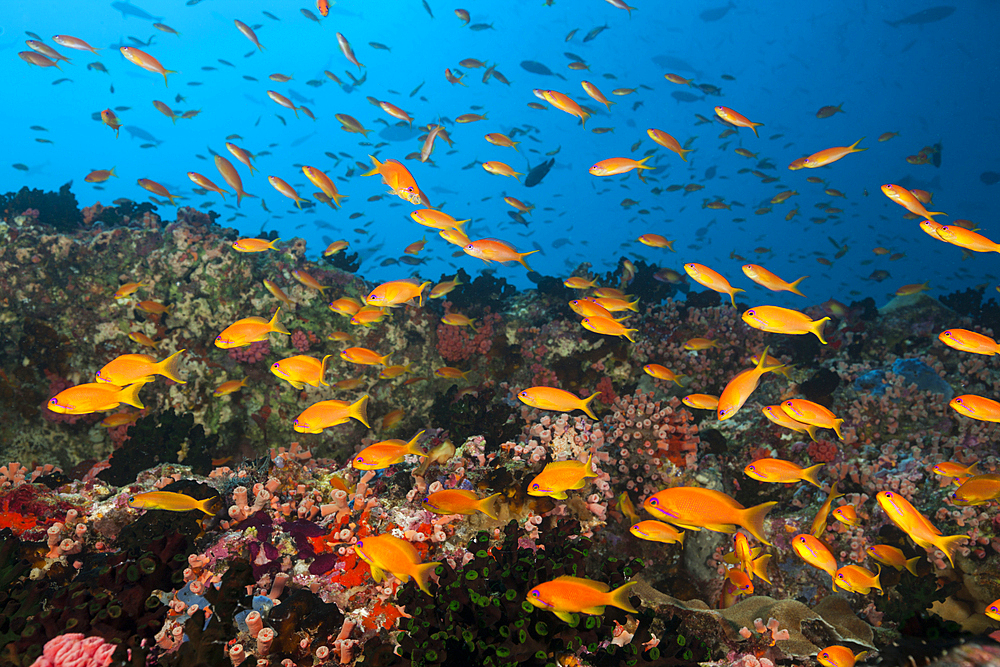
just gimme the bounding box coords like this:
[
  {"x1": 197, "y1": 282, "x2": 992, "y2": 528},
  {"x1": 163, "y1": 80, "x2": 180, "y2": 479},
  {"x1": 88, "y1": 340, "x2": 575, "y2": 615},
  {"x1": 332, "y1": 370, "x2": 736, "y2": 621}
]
[{"x1": 642, "y1": 486, "x2": 778, "y2": 545}]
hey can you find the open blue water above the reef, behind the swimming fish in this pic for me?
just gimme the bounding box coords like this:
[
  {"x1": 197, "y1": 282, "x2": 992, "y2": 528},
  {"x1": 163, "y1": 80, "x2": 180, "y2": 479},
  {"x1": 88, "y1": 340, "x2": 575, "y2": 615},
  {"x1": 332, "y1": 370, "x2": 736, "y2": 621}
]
[{"x1": 0, "y1": 0, "x2": 1000, "y2": 305}]
